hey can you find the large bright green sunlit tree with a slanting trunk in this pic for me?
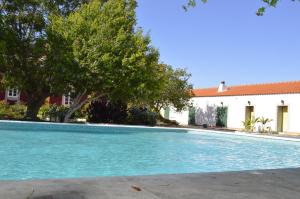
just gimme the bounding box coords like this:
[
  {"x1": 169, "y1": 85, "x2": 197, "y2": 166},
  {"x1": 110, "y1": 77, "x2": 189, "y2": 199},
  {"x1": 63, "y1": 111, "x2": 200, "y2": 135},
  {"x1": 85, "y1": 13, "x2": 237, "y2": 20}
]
[{"x1": 51, "y1": 0, "x2": 159, "y2": 121}]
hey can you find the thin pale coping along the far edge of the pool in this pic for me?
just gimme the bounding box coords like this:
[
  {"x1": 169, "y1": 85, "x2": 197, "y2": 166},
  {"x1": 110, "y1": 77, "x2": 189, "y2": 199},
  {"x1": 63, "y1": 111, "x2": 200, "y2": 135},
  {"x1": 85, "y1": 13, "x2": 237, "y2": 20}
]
[{"x1": 0, "y1": 120, "x2": 300, "y2": 142}]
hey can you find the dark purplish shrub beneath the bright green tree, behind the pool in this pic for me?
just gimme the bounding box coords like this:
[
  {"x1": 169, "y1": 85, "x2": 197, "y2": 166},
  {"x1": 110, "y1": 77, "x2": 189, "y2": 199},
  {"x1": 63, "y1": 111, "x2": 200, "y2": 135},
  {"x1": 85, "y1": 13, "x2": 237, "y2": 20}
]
[{"x1": 87, "y1": 99, "x2": 127, "y2": 124}]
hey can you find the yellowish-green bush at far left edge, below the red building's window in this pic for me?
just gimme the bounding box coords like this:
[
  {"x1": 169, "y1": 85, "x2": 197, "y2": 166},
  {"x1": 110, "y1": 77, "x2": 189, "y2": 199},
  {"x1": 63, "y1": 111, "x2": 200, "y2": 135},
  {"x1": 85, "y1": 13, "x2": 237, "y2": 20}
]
[{"x1": 0, "y1": 101, "x2": 26, "y2": 119}]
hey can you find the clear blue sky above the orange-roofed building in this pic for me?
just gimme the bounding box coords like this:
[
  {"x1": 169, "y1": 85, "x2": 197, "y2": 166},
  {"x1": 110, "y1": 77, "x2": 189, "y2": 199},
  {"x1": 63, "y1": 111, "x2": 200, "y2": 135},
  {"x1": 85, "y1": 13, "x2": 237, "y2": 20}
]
[{"x1": 137, "y1": 0, "x2": 300, "y2": 88}]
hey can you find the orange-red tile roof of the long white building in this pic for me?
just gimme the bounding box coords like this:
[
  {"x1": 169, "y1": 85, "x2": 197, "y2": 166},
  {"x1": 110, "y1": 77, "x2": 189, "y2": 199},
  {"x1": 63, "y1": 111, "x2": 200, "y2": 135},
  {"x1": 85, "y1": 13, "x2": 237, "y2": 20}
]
[{"x1": 193, "y1": 81, "x2": 300, "y2": 97}]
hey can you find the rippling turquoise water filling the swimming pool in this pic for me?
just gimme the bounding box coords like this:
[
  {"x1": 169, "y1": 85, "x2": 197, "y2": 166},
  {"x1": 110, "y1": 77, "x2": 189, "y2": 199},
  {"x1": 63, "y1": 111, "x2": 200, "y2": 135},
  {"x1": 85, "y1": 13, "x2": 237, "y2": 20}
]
[{"x1": 0, "y1": 122, "x2": 300, "y2": 179}]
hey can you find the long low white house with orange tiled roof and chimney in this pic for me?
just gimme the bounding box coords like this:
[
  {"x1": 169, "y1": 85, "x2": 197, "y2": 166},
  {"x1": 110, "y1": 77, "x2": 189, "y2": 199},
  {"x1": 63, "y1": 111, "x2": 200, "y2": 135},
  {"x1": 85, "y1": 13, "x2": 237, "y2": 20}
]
[{"x1": 164, "y1": 81, "x2": 300, "y2": 132}]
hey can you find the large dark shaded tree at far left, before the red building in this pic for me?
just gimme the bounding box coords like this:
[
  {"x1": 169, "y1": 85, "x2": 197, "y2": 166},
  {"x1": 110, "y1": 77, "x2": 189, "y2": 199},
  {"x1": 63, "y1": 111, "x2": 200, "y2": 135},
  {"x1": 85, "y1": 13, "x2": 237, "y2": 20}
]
[{"x1": 0, "y1": 0, "x2": 85, "y2": 120}]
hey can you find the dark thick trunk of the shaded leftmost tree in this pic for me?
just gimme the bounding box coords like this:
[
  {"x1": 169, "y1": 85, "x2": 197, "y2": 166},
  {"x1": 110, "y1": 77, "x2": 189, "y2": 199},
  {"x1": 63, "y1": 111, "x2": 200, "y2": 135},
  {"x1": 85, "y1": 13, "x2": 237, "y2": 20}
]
[{"x1": 25, "y1": 94, "x2": 48, "y2": 121}]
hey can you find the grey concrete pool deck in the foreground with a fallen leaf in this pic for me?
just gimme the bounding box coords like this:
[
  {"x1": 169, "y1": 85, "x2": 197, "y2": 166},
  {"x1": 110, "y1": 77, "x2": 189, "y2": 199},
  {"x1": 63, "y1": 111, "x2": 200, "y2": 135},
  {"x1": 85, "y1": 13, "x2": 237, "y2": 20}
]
[{"x1": 0, "y1": 168, "x2": 300, "y2": 199}]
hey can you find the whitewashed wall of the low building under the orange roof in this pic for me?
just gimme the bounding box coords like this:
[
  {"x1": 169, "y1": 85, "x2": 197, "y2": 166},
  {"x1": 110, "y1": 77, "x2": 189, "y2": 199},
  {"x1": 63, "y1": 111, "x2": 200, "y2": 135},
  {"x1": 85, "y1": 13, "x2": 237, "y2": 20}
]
[{"x1": 166, "y1": 94, "x2": 300, "y2": 132}]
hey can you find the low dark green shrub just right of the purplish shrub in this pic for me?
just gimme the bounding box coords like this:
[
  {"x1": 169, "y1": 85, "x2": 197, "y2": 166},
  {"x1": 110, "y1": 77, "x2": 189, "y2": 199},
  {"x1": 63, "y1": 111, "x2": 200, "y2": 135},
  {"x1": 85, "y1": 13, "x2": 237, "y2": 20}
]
[{"x1": 128, "y1": 107, "x2": 157, "y2": 126}]
